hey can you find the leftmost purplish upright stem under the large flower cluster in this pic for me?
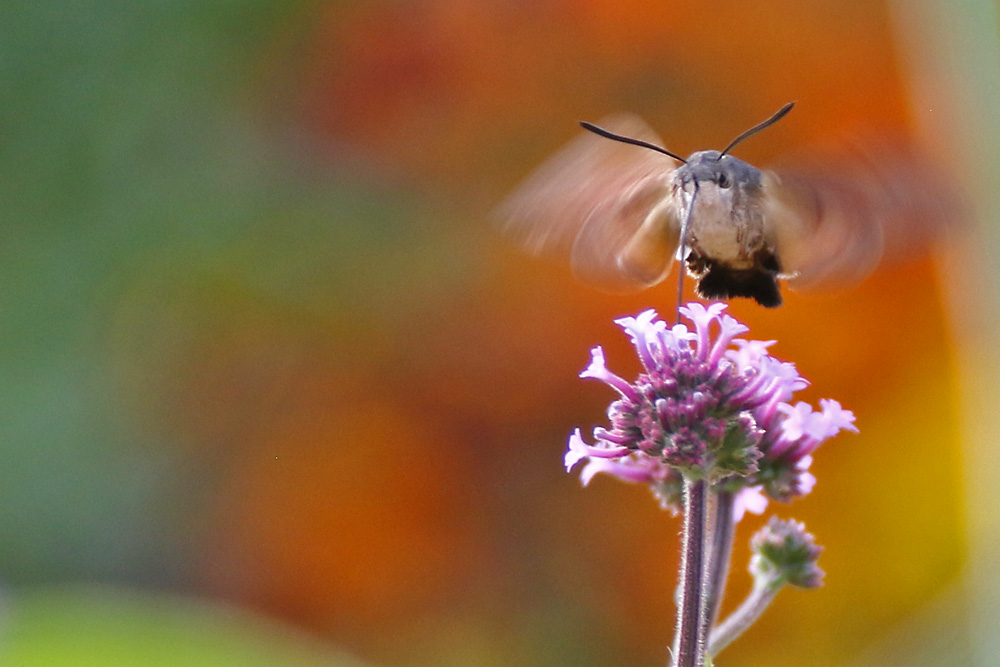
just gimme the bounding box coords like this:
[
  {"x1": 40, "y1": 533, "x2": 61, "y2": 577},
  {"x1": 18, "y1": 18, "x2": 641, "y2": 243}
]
[{"x1": 674, "y1": 478, "x2": 708, "y2": 667}]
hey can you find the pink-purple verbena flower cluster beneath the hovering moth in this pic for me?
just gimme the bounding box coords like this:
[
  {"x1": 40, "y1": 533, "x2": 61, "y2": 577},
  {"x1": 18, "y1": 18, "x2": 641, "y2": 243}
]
[{"x1": 565, "y1": 302, "x2": 856, "y2": 514}]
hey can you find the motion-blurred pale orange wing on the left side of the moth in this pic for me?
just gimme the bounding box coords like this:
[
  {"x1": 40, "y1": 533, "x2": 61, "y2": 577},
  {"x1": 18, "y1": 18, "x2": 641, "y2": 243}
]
[{"x1": 496, "y1": 115, "x2": 680, "y2": 291}]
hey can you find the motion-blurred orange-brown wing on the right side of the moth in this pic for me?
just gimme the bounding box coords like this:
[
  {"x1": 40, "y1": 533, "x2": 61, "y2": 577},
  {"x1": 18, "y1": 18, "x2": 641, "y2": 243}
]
[{"x1": 763, "y1": 144, "x2": 963, "y2": 288}]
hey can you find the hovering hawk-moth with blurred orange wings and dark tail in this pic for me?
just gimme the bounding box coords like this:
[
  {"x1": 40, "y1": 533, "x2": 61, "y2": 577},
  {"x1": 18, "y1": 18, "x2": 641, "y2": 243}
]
[{"x1": 497, "y1": 103, "x2": 950, "y2": 307}]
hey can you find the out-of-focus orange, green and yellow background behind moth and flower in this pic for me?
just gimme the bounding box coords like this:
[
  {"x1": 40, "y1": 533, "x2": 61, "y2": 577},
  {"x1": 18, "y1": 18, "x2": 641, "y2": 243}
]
[{"x1": 0, "y1": 0, "x2": 1000, "y2": 667}]
